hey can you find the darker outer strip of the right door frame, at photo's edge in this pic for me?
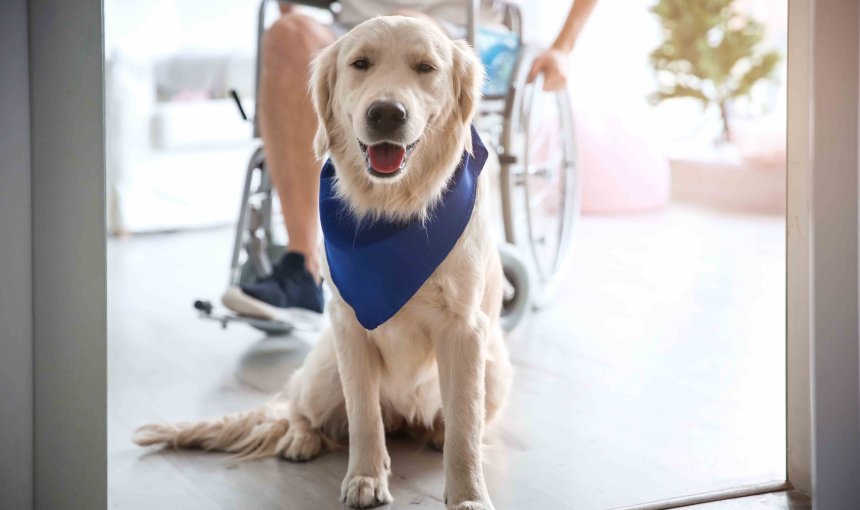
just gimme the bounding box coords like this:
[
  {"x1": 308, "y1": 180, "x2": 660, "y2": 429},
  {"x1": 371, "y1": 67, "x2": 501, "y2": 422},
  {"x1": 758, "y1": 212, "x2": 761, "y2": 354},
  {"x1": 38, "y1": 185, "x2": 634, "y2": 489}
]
[{"x1": 808, "y1": 0, "x2": 860, "y2": 510}]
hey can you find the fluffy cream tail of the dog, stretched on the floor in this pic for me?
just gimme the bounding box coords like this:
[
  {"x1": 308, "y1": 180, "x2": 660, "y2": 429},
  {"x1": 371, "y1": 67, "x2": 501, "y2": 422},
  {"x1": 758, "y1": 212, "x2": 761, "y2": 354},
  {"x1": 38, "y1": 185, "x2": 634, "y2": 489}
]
[{"x1": 132, "y1": 404, "x2": 290, "y2": 459}]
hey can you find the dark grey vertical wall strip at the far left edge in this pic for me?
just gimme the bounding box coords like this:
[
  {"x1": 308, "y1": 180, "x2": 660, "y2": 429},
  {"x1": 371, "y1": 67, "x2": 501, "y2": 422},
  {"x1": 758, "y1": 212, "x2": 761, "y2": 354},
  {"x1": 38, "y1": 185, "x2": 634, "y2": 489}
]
[{"x1": 0, "y1": 0, "x2": 33, "y2": 509}]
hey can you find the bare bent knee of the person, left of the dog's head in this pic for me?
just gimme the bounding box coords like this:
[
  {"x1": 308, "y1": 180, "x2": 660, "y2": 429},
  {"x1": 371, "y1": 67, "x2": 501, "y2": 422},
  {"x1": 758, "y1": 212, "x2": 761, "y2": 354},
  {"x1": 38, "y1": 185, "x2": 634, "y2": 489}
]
[{"x1": 263, "y1": 13, "x2": 334, "y2": 67}]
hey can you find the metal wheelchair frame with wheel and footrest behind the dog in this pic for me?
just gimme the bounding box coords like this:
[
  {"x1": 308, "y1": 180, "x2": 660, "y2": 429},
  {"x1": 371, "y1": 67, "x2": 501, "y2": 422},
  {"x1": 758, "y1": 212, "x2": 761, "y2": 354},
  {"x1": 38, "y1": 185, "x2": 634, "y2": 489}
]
[{"x1": 213, "y1": 0, "x2": 579, "y2": 333}]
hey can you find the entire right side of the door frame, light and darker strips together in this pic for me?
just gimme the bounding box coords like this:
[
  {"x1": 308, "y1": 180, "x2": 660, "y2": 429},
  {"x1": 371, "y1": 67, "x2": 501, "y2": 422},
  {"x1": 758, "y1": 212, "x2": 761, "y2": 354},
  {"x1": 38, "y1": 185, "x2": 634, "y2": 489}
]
[{"x1": 787, "y1": 0, "x2": 860, "y2": 510}]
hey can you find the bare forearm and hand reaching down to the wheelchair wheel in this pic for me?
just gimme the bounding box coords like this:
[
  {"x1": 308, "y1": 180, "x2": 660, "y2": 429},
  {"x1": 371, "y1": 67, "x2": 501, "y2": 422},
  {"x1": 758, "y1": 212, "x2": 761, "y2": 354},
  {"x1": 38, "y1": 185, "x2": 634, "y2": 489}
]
[{"x1": 528, "y1": 0, "x2": 597, "y2": 91}]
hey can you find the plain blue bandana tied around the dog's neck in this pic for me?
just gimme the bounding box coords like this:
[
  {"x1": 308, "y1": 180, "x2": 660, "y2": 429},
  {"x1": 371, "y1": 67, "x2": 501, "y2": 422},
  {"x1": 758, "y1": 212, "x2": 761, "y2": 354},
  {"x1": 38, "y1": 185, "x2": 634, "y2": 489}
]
[{"x1": 320, "y1": 127, "x2": 487, "y2": 330}]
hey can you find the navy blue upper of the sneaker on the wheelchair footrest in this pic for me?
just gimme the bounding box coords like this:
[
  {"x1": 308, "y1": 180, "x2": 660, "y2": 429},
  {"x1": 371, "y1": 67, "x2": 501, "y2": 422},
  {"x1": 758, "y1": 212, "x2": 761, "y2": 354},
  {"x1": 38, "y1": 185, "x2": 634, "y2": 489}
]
[{"x1": 241, "y1": 252, "x2": 323, "y2": 313}]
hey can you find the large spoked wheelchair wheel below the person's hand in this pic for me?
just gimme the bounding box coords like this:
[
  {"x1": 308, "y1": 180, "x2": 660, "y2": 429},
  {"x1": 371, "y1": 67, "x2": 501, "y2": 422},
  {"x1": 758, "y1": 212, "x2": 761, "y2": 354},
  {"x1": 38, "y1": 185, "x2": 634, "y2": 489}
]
[{"x1": 500, "y1": 52, "x2": 579, "y2": 307}]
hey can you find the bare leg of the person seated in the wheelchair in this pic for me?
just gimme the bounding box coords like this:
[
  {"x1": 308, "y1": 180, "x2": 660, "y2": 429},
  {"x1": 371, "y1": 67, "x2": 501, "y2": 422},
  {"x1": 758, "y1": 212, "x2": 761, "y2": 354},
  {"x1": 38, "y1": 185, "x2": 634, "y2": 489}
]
[{"x1": 259, "y1": 13, "x2": 335, "y2": 278}]
